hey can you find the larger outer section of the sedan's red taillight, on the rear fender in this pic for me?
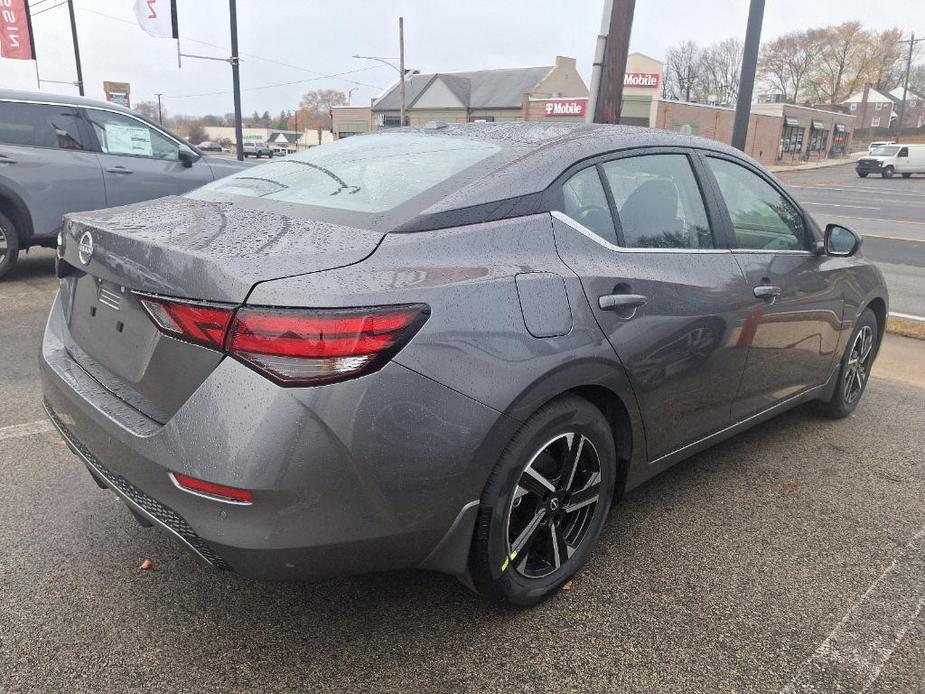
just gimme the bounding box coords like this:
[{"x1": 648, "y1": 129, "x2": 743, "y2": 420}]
[{"x1": 225, "y1": 304, "x2": 427, "y2": 385}]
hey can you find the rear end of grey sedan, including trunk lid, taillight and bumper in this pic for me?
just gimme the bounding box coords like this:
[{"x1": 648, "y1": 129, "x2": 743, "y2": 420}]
[{"x1": 41, "y1": 132, "x2": 520, "y2": 578}]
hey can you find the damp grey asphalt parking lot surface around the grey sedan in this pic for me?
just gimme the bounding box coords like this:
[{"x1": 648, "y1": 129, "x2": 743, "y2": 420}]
[{"x1": 0, "y1": 251, "x2": 925, "y2": 694}]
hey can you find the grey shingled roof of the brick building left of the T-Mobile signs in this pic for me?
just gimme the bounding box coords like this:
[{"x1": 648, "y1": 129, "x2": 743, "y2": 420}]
[{"x1": 373, "y1": 65, "x2": 554, "y2": 111}]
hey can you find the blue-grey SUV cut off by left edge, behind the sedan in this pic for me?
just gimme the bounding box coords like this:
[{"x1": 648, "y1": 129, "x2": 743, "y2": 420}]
[{"x1": 0, "y1": 89, "x2": 249, "y2": 278}]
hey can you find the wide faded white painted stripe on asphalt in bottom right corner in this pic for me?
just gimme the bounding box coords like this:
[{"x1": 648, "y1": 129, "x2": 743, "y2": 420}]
[{"x1": 780, "y1": 528, "x2": 925, "y2": 694}]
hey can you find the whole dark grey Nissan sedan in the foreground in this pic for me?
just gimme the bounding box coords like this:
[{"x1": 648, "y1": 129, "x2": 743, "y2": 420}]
[{"x1": 41, "y1": 123, "x2": 888, "y2": 605}]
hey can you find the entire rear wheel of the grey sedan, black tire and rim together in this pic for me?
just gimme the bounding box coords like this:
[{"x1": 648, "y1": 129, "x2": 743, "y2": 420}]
[{"x1": 469, "y1": 396, "x2": 617, "y2": 607}]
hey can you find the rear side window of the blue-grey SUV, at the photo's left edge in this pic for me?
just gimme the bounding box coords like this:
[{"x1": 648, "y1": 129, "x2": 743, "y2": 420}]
[{"x1": 0, "y1": 101, "x2": 88, "y2": 150}]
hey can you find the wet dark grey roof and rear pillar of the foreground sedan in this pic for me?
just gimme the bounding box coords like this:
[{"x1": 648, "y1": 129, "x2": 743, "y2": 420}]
[{"x1": 382, "y1": 121, "x2": 752, "y2": 216}]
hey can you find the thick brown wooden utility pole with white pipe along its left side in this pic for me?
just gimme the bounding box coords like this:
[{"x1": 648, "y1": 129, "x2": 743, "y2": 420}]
[{"x1": 588, "y1": 0, "x2": 636, "y2": 123}]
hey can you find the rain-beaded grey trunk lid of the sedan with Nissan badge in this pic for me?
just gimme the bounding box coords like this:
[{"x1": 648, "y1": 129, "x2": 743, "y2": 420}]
[{"x1": 59, "y1": 197, "x2": 383, "y2": 422}]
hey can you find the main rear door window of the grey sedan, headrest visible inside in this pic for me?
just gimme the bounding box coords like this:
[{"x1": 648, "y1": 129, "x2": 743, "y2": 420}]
[{"x1": 602, "y1": 154, "x2": 716, "y2": 248}]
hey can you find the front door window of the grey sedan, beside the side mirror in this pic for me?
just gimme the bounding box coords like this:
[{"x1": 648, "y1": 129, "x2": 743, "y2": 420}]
[{"x1": 707, "y1": 157, "x2": 806, "y2": 251}]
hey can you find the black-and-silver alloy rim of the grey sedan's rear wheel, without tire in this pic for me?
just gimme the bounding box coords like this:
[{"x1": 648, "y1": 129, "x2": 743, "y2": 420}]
[{"x1": 507, "y1": 432, "x2": 601, "y2": 578}]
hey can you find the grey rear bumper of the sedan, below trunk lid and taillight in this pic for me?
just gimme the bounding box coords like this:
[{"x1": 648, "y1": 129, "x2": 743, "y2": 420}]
[{"x1": 41, "y1": 300, "x2": 509, "y2": 579}]
